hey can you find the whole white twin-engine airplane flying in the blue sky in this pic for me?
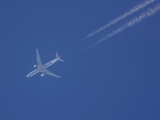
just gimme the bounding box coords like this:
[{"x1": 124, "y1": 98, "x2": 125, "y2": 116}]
[{"x1": 26, "y1": 48, "x2": 64, "y2": 78}]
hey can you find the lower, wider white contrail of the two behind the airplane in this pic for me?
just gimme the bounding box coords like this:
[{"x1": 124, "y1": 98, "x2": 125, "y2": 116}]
[{"x1": 96, "y1": 3, "x2": 160, "y2": 44}]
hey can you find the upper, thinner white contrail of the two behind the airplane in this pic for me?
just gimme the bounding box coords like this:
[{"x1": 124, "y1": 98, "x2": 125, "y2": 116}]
[{"x1": 82, "y1": 0, "x2": 155, "y2": 40}]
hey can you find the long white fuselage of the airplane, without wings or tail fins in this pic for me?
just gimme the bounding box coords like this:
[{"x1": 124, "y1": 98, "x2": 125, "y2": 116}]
[{"x1": 27, "y1": 57, "x2": 60, "y2": 77}]
